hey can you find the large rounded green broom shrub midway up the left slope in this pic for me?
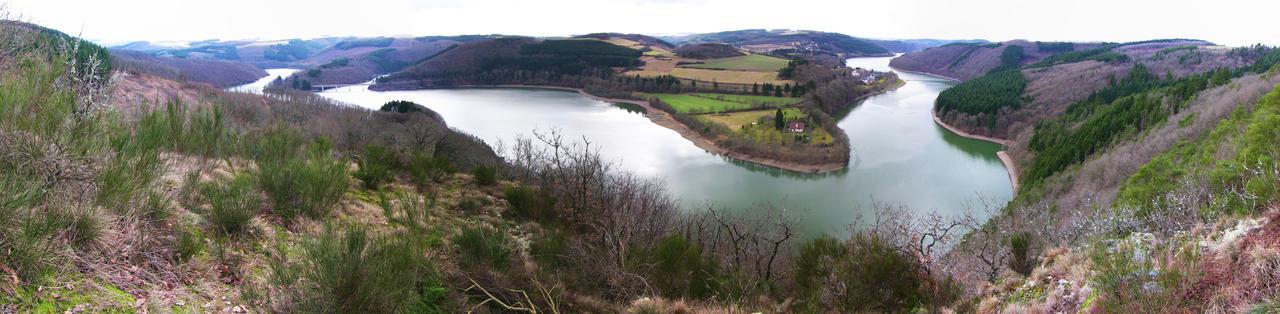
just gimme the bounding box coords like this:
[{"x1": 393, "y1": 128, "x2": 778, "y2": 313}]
[{"x1": 253, "y1": 131, "x2": 351, "y2": 220}]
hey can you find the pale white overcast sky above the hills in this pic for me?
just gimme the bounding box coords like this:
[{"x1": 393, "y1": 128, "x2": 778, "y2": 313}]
[{"x1": 0, "y1": 0, "x2": 1280, "y2": 46}]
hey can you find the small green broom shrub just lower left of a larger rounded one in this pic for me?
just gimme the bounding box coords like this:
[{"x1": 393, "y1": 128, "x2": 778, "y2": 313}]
[{"x1": 200, "y1": 176, "x2": 262, "y2": 236}]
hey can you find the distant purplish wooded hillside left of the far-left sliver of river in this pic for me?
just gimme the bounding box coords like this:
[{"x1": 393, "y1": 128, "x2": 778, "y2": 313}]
[{"x1": 111, "y1": 49, "x2": 266, "y2": 88}]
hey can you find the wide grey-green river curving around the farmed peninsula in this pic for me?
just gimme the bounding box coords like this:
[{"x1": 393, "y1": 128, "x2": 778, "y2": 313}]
[{"x1": 312, "y1": 58, "x2": 1012, "y2": 235}]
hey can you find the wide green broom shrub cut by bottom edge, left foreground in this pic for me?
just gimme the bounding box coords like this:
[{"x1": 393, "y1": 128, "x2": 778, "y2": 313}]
[{"x1": 269, "y1": 224, "x2": 445, "y2": 313}]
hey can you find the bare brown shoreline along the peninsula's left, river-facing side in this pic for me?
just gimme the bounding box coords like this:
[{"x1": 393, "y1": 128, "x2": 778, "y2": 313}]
[{"x1": 457, "y1": 85, "x2": 849, "y2": 173}]
